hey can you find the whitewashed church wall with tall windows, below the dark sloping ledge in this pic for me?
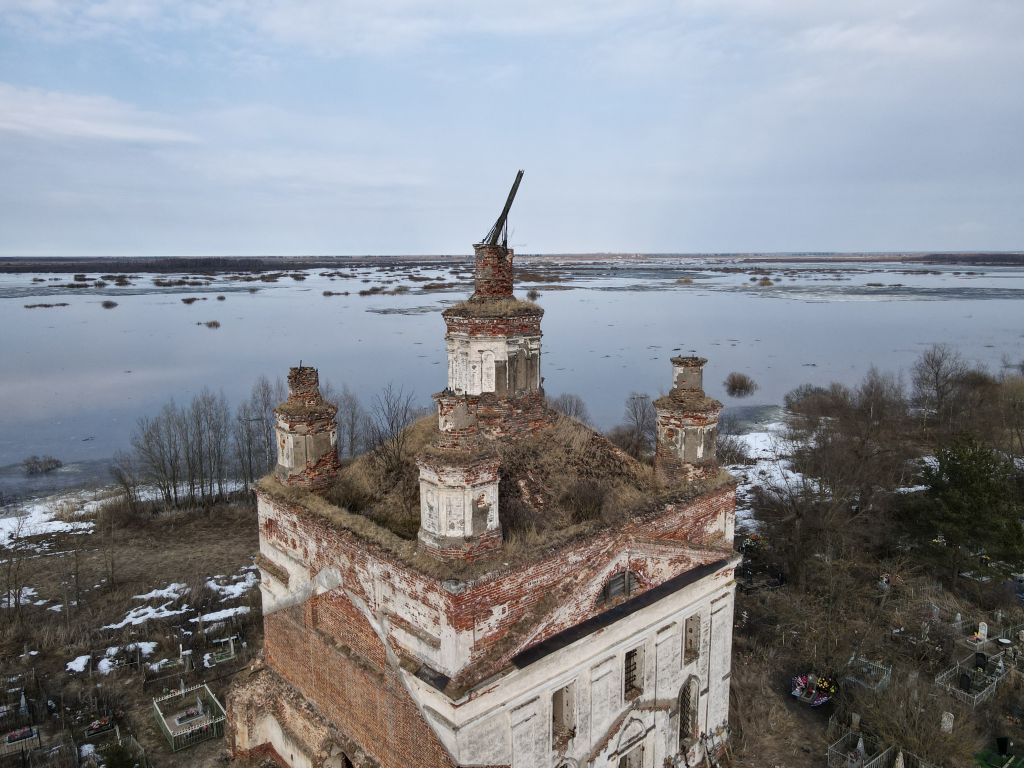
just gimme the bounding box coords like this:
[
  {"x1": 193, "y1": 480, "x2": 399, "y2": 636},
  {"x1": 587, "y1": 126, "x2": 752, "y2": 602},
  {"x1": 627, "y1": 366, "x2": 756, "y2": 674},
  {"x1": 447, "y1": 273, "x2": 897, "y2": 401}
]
[{"x1": 410, "y1": 575, "x2": 734, "y2": 768}]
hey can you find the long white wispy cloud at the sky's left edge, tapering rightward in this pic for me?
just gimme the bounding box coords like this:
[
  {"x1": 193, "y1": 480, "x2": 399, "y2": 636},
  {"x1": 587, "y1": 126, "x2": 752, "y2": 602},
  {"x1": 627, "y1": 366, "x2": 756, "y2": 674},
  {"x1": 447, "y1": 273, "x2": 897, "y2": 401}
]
[{"x1": 0, "y1": 83, "x2": 197, "y2": 144}]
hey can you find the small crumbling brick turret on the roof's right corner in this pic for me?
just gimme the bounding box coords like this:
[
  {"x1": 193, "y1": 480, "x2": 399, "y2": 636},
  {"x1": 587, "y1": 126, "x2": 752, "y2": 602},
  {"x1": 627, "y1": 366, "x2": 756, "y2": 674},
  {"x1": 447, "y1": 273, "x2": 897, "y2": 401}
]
[{"x1": 654, "y1": 356, "x2": 722, "y2": 484}]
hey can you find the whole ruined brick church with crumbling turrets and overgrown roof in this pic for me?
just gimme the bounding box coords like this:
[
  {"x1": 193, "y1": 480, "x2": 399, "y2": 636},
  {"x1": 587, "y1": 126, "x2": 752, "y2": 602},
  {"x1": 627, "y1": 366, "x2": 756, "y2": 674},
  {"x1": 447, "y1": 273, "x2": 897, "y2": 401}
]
[{"x1": 227, "y1": 177, "x2": 738, "y2": 768}]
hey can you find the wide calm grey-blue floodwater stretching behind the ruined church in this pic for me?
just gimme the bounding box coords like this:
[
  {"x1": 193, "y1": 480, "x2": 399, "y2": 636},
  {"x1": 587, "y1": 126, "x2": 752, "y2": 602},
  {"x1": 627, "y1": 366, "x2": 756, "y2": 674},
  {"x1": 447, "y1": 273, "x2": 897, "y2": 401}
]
[{"x1": 0, "y1": 257, "x2": 1024, "y2": 493}]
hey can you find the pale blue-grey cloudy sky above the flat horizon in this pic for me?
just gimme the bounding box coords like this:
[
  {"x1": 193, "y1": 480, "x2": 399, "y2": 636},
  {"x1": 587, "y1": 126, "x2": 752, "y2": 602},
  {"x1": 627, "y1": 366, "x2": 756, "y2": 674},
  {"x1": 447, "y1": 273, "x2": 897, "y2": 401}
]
[{"x1": 0, "y1": 0, "x2": 1024, "y2": 255}]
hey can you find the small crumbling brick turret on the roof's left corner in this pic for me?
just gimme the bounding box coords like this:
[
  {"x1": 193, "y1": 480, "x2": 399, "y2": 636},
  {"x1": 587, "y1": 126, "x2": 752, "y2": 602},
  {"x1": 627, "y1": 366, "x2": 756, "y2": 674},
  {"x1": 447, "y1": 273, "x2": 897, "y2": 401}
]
[{"x1": 273, "y1": 366, "x2": 341, "y2": 488}]
